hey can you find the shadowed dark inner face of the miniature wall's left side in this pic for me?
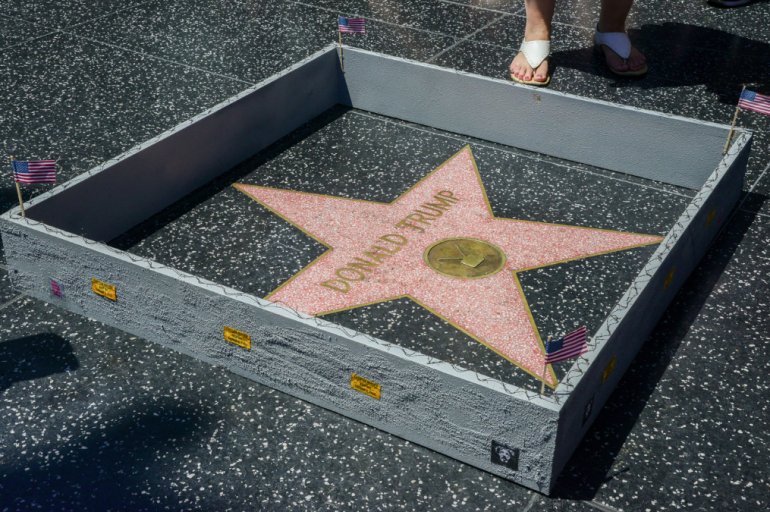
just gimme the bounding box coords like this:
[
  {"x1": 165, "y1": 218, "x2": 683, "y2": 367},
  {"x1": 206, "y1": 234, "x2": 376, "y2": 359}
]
[{"x1": 27, "y1": 48, "x2": 346, "y2": 241}]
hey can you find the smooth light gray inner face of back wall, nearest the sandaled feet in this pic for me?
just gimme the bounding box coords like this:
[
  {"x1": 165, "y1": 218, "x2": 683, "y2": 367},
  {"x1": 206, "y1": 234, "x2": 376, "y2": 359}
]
[{"x1": 345, "y1": 48, "x2": 728, "y2": 189}]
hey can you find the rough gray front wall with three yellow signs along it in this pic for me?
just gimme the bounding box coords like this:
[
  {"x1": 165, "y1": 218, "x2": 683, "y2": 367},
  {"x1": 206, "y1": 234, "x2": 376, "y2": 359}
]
[{"x1": 0, "y1": 219, "x2": 558, "y2": 492}]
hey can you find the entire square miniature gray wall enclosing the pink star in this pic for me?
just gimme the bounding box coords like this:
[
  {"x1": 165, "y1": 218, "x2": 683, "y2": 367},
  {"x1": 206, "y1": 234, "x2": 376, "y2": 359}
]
[{"x1": 0, "y1": 47, "x2": 750, "y2": 491}]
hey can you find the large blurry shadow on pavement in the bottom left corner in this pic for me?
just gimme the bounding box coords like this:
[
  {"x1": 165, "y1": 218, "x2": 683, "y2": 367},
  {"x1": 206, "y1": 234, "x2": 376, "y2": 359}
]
[{"x1": 0, "y1": 399, "x2": 214, "y2": 510}]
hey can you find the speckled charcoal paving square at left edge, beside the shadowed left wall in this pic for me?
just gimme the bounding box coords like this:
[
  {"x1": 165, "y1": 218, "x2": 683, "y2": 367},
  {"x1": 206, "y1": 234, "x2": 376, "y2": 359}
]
[{"x1": 0, "y1": 33, "x2": 246, "y2": 214}]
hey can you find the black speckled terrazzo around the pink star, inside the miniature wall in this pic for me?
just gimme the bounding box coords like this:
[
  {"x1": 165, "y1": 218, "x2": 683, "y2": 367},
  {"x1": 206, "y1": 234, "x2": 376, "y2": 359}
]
[{"x1": 108, "y1": 107, "x2": 694, "y2": 390}]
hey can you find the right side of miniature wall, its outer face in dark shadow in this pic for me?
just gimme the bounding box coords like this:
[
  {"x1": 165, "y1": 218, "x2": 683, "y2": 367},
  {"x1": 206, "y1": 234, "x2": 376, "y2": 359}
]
[{"x1": 554, "y1": 133, "x2": 751, "y2": 486}]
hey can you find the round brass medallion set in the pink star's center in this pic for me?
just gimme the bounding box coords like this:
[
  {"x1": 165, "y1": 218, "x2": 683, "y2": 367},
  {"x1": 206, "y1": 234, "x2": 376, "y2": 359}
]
[{"x1": 423, "y1": 238, "x2": 505, "y2": 279}]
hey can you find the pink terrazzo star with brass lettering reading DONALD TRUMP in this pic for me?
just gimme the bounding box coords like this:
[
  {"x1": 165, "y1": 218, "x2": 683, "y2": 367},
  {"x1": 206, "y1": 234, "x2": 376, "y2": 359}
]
[{"x1": 235, "y1": 146, "x2": 661, "y2": 386}]
